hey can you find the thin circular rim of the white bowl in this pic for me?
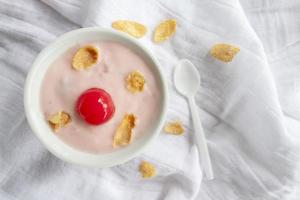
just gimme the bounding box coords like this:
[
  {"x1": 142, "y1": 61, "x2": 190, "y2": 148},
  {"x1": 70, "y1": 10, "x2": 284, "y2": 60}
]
[{"x1": 23, "y1": 27, "x2": 168, "y2": 168}]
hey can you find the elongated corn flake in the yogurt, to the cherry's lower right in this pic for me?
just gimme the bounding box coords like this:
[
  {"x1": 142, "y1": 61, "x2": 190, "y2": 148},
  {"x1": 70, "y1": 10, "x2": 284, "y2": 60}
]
[{"x1": 113, "y1": 114, "x2": 136, "y2": 147}]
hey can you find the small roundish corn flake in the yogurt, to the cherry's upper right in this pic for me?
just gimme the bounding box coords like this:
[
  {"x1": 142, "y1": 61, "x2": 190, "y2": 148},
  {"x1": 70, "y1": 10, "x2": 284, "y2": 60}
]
[{"x1": 126, "y1": 71, "x2": 146, "y2": 93}]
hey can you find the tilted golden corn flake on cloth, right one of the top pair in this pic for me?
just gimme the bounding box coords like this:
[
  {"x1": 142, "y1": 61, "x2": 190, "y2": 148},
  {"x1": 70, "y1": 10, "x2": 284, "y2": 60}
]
[{"x1": 153, "y1": 19, "x2": 176, "y2": 43}]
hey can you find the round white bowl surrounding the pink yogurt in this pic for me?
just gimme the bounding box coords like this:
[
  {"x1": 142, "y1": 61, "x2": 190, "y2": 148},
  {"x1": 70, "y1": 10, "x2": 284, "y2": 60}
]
[{"x1": 24, "y1": 27, "x2": 167, "y2": 168}]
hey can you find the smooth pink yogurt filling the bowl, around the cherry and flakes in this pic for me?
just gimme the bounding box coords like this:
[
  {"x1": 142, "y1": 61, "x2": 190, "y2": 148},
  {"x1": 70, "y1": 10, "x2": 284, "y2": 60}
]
[{"x1": 41, "y1": 41, "x2": 161, "y2": 154}]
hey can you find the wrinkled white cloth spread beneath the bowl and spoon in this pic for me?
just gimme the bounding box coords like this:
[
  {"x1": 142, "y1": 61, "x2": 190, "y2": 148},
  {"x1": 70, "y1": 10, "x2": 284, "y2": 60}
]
[{"x1": 0, "y1": 0, "x2": 300, "y2": 200}]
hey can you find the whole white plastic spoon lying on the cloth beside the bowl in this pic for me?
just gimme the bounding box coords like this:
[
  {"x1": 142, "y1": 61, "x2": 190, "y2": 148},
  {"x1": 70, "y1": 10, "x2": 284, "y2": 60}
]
[{"x1": 174, "y1": 59, "x2": 214, "y2": 180}]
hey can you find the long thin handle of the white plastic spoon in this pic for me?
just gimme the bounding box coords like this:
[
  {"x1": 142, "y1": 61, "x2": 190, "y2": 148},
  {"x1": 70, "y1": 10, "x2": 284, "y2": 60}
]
[{"x1": 188, "y1": 97, "x2": 214, "y2": 180}]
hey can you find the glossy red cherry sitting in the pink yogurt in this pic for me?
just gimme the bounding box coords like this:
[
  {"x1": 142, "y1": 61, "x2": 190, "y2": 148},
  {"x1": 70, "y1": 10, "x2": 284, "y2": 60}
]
[{"x1": 76, "y1": 88, "x2": 115, "y2": 125}]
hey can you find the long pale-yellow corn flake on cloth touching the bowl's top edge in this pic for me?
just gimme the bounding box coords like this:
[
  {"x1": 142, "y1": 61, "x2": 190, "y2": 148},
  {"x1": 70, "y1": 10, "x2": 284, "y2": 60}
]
[{"x1": 111, "y1": 20, "x2": 147, "y2": 38}]
